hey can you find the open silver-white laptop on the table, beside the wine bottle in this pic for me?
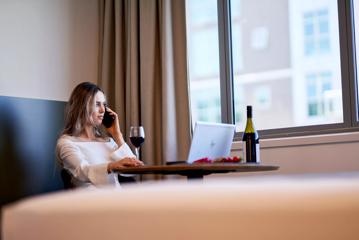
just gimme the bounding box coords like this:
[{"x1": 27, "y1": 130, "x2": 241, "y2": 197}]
[{"x1": 167, "y1": 122, "x2": 235, "y2": 165}]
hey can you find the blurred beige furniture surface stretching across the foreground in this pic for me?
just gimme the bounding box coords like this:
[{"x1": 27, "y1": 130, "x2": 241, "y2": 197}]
[{"x1": 2, "y1": 173, "x2": 359, "y2": 240}]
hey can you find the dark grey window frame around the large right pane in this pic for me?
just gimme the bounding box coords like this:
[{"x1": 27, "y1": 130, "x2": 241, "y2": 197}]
[{"x1": 217, "y1": 0, "x2": 359, "y2": 141}]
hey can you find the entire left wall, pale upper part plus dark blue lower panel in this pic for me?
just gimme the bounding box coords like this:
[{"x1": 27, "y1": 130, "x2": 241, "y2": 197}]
[{"x1": 0, "y1": 0, "x2": 99, "y2": 206}]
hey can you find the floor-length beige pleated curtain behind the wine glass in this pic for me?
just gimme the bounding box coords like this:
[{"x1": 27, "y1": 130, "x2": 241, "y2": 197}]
[{"x1": 99, "y1": 0, "x2": 190, "y2": 169}]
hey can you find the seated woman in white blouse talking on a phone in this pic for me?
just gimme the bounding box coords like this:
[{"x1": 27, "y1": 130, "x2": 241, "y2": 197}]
[{"x1": 56, "y1": 82, "x2": 143, "y2": 187}]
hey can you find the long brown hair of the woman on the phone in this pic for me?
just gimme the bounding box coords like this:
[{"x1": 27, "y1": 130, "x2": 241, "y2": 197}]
[{"x1": 62, "y1": 82, "x2": 105, "y2": 137}]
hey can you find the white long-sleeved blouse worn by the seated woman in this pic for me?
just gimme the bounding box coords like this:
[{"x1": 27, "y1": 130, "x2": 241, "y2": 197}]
[{"x1": 56, "y1": 135, "x2": 135, "y2": 187}]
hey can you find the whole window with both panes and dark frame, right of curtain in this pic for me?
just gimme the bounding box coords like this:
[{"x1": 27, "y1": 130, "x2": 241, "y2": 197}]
[{"x1": 187, "y1": 0, "x2": 359, "y2": 137}]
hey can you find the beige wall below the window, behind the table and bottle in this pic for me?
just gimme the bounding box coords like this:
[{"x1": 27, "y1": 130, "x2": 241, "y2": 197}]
[{"x1": 210, "y1": 132, "x2": 359, "y2": 178}]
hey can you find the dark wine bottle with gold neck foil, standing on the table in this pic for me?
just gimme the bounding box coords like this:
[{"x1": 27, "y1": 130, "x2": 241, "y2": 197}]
[{"x1": 242, "y1": 106, "x2": 260, "y2": 163}]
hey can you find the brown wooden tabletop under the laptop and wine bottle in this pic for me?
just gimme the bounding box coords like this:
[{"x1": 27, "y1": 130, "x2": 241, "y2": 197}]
[{"x1": 116, "y1": 163, "x2": 279, "y2": 179}]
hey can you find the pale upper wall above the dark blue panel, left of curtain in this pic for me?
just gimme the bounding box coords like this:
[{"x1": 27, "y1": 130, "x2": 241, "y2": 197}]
[{"x1": 0, "y1": 0, "x2": 98, "y2": 101}]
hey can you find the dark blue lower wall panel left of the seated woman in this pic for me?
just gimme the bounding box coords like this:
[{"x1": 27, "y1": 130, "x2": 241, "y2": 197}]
[{"x1": 0, "y1": 96, "x2": 65, "y2": 207}]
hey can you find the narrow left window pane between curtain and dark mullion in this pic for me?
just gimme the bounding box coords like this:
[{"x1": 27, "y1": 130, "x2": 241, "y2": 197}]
[{"x1": 186, "y1": 0, "x2": 221, "y2": 122}]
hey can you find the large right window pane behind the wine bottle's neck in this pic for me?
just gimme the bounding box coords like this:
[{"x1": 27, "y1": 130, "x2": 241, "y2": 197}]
[{"x1": 231, "y1": 0, "x2": 343, "y2": 131}]
